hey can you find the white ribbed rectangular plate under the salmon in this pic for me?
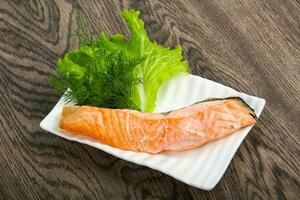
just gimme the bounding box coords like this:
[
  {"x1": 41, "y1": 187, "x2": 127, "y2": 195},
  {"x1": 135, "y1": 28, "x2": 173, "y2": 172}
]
[{"x1": 40, "y1": 75, "x2": 265, "y2": 190}]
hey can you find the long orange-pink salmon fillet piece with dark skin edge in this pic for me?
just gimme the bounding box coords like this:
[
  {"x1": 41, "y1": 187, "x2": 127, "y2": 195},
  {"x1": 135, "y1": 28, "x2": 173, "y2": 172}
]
[{"x1": 59, "y1": 97, "x2": 257, "y2": 153}]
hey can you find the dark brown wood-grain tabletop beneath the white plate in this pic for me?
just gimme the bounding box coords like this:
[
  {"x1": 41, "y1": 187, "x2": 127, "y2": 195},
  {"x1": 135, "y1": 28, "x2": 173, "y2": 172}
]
[{"x1": 0, "y1": 0, "x2": 300, "y2": 199}]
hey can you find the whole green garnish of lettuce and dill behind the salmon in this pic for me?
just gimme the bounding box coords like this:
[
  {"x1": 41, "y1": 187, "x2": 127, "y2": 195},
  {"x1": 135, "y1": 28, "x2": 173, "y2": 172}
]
[{"x1": 51, "y1": 10, "x2": 188, "y2": 112}]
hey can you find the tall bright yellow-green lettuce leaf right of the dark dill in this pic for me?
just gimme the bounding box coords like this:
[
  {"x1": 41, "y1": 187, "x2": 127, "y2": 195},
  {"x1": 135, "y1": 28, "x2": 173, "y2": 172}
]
[{"x1": 118, "y1": 10, "x2": 189, "y2": 112}]
